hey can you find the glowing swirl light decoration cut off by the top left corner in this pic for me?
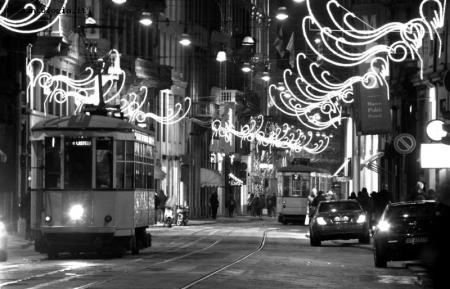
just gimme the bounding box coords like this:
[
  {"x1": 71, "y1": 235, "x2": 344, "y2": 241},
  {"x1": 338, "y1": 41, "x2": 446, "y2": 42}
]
[{"x1": 0, "y1": 0, "x2": 67, "y2": 34}]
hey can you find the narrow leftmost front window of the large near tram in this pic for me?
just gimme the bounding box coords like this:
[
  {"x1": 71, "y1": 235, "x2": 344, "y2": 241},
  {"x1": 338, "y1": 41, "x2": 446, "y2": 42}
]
[{"x1": 45, "y1": 137, "x2": 61, "y2": 189}]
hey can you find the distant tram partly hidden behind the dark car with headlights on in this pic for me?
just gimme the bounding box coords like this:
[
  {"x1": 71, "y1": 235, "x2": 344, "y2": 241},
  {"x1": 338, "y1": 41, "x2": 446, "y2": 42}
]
[{"x1": 277, "y1": 165, "x2": 332, "y2": 225}]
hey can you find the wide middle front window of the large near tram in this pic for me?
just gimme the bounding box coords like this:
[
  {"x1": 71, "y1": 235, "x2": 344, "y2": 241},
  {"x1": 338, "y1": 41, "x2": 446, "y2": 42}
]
[{"x1": 64, "y1": 137, "x2": 92, "y2": 189}]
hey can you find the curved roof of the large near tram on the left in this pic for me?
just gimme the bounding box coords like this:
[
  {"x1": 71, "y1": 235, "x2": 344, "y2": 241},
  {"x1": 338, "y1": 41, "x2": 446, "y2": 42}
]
[{"x1": 31, "y1": 114, "x2": 150, "y2": 134}]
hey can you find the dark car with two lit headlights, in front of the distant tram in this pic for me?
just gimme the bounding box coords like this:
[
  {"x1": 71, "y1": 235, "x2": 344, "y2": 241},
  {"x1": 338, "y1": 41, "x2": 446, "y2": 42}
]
[{"x1": 309, "y1": 200, "x2": 370, "y2": 246}]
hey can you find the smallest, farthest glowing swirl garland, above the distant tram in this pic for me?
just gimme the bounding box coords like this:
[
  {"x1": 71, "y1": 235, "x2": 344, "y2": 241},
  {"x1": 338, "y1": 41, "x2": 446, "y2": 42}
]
[{"x1": 212, "y1": 109, "x2": 330, "y2": 154}]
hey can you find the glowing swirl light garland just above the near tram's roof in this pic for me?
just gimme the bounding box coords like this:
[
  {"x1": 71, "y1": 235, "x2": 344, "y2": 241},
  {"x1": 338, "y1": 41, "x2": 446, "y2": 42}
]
[{"x1": 27, "y1": 49, "x2": 191, "y2": 124}]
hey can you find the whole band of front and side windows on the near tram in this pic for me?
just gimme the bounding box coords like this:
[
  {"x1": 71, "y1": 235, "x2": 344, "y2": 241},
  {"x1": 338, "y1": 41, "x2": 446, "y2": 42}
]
[{"x1": 44, "y1": 136, "x2": 154, "y2": 189}]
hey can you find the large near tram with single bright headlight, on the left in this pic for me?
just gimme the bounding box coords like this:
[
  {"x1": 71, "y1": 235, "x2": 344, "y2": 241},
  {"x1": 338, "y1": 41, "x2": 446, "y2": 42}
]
[{"x1": 30, "y1": 113, "x2": 155, "y2": 259}]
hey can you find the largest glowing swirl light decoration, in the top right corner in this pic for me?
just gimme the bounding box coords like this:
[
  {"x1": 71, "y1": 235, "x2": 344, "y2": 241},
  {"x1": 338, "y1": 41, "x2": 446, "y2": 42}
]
[{"x1": 302, "y1": 0, "x2": 446, "y2": 77}]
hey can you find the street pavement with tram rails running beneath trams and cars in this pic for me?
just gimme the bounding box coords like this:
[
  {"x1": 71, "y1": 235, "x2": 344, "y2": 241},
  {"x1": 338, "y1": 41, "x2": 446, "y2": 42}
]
[{"x1": 0, "y1": 216, "x2": 431, "y2": 289}]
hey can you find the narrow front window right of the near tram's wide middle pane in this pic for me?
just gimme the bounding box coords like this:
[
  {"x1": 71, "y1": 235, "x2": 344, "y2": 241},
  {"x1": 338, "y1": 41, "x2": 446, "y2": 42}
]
[{"x1": 96, "y1": 138, "x2": 113, "y2": 189}]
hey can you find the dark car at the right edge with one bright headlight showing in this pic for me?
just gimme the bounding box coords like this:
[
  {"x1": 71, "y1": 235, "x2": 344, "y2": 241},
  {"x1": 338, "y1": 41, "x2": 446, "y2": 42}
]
[{"x1": 373, "y1": 201, "x2": 436, "y2": 267}]
